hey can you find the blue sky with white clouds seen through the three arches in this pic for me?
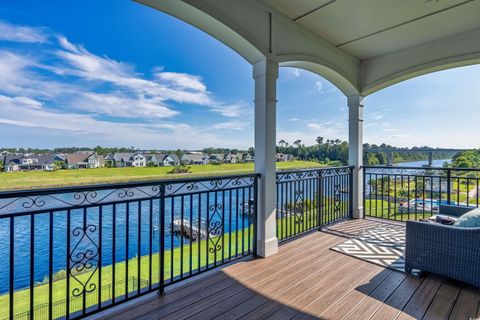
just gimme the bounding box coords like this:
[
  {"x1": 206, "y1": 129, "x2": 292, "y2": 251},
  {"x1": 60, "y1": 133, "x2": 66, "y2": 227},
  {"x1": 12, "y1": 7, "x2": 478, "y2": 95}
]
[{"x1": 0, "y1": 0, "x2": 480, "y2": 149}]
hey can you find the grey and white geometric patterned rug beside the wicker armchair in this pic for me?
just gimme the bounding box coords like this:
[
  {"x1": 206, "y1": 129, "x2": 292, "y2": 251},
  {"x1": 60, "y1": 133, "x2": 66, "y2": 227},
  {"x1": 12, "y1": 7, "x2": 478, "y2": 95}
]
[{"x1": 331, "y1": 226, "x2": 405, "y2": 272}]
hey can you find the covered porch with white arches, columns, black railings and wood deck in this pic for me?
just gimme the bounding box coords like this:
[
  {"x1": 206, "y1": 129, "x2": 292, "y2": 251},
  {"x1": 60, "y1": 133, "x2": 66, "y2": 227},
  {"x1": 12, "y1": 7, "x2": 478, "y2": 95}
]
[{"x1": 0, "y1": 0, "x2": 480, "y2": 319}]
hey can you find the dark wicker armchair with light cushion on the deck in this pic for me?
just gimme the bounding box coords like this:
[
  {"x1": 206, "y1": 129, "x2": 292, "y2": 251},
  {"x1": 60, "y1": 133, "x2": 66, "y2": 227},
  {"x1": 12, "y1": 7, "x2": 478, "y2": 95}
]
[{"x1": 405, "y1": 206, "x2": 480, "y2": 287}]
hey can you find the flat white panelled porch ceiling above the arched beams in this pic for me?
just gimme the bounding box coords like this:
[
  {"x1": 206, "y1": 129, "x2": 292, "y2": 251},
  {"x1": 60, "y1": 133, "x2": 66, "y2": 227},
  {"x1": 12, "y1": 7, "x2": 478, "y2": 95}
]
[{"x1": 263, "y1": 0, "x2": 480, "y2": 59}]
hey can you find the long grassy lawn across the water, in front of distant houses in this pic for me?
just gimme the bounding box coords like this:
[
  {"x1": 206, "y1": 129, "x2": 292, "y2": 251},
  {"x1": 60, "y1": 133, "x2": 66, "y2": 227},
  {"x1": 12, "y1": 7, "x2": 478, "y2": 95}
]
[{"x1": 0, "y1": 161, "x2": 330, "y2": 190}]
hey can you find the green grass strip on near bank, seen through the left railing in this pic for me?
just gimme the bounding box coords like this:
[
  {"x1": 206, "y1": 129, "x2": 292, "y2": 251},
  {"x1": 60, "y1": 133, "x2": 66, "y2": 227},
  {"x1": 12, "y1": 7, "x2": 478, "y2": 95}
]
[{"x1": 0, "y1": 227, "x2": 253, "y2": 319}]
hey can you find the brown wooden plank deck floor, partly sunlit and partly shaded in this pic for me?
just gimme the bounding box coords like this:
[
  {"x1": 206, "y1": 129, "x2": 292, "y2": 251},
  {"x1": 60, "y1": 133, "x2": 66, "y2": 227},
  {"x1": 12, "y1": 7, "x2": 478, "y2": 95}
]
[{"x1": 99, "y1": 220, "x2": 480, "y2": 320}]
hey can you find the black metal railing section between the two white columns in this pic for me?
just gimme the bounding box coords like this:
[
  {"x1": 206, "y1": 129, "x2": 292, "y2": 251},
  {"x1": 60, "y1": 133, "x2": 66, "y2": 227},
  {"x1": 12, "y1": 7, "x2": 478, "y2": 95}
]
[{"x1": 276, "y1": 167, "x2": 353, "y2": 241}]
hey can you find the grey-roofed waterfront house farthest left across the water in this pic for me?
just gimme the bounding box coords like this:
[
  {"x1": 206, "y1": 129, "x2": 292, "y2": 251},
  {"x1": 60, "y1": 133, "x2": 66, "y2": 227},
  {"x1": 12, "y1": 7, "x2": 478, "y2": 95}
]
[{"x1": 3, "y1": 154, "x2": 62, "y2": 172}]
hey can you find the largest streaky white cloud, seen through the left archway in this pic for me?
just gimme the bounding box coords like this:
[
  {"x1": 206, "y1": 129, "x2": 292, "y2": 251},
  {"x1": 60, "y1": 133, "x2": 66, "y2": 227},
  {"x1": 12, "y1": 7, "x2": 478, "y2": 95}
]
[{"x1": 0, "y1": 29, "x2": 251, "y2": 122}]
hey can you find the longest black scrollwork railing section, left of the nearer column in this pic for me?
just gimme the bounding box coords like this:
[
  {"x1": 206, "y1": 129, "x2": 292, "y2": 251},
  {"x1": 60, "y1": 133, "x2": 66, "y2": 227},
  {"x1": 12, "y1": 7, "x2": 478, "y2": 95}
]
[{"x1": 0, "y1": 174, "x2": 258, "y2": 319}]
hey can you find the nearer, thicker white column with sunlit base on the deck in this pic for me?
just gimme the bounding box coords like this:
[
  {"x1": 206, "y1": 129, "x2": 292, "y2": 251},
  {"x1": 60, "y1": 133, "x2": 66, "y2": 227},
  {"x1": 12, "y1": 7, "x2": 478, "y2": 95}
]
[{"x1": 253, "y1": 59, "x2": 278, "y2": 257}]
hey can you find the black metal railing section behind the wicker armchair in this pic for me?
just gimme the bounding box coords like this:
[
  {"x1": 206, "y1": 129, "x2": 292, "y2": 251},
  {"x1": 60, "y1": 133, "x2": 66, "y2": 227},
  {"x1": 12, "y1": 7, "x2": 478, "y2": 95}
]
[{"x1": 363, "y1": 166, "x2": 480, "y2": 221}]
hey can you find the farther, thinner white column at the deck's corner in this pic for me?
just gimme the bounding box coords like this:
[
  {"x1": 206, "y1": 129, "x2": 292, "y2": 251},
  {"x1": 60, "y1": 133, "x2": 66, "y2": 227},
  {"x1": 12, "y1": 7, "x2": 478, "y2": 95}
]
[{"x1": 348, "y1": 96, "x2": 363, "y2": 218}]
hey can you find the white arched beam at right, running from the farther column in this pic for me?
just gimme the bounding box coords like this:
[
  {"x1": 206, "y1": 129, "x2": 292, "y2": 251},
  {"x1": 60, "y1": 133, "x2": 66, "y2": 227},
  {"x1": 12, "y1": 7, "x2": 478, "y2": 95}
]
[{"x1": 361, "y1": 29, "x2": 480, "y2": 96}]
